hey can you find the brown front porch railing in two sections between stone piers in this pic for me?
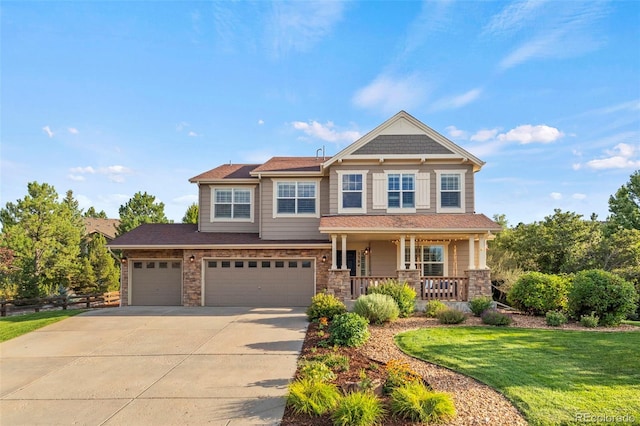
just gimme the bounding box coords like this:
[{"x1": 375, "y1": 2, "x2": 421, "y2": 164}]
[{"x1": 351, "y1": 276, "x2": 469, "y2": 301}]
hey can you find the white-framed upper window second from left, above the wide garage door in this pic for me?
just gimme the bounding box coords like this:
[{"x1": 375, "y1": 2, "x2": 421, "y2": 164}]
[{"x1": 274, "y1": 181, "x2": 319, "y2": 217}]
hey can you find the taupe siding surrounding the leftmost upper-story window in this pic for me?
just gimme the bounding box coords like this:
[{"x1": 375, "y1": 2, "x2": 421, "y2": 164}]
[{"x1": 199, "y1": 184, "x2": 260, "y2": 234}]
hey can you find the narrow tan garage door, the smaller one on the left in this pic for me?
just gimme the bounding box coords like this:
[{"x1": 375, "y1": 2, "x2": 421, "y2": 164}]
[{"x1": 131, "y1": 260, "x2": 182, "y2": 306}]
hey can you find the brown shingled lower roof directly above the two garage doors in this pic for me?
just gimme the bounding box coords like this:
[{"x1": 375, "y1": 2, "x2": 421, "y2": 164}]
[{"x1": 108, "y1": 223, "x2": 331, "y2": 249}]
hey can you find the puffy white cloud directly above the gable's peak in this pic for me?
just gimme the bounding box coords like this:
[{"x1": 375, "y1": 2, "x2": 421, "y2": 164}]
[{"x1": 352, "y1": 74, "x2": 427, "y2": 114}]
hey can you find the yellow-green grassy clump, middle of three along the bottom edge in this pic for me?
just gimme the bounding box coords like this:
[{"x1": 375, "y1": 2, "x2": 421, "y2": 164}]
[{"x1": 331, "y1": 392, "x2": 384, "y2": 426}]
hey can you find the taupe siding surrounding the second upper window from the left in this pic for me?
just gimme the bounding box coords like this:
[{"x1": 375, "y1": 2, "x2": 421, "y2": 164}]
[{"x1": 260, "y1": 177, "x2": 329, "y2": 240}]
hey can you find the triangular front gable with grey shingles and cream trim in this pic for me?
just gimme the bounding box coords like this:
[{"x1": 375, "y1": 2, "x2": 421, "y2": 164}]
[{"x1": 324, "y1": 111, "x2": 484, "y2": 170}]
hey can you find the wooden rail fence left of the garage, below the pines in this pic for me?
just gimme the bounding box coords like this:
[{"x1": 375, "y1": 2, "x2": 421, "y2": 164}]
[{"x1": 0, "y1": 291, "x2": 120, "y2": 317}]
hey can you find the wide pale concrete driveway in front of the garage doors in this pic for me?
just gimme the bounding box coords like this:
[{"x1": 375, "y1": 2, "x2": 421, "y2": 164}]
[{"x1": 0, "y1": 307, "x2": 306, "y2": 426}]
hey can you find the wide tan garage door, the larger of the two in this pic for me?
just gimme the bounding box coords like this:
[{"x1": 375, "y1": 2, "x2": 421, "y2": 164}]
[{"x1": 204, "y1": 259, "x2": 315, "y2": 307}]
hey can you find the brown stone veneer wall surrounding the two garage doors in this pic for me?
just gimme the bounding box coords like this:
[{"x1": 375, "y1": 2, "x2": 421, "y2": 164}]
[{"x1": 120, "y1": 249, "x2": 331, "y2": 306}]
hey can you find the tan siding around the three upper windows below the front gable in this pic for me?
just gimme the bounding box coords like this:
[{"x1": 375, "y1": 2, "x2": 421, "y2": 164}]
[{"x1": 328, "y1": 164, "x2": 475, "y2": 215}]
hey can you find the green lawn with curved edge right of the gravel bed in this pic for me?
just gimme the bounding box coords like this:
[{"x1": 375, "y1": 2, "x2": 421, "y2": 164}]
[{"x1": 396, "y1": 327, "x2": 640, "y2": 425}]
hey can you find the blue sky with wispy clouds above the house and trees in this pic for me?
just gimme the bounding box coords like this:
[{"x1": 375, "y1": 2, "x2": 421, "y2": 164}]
[{"x1": 0, "y1": 1, "x2": 640, "y2": 224}]
